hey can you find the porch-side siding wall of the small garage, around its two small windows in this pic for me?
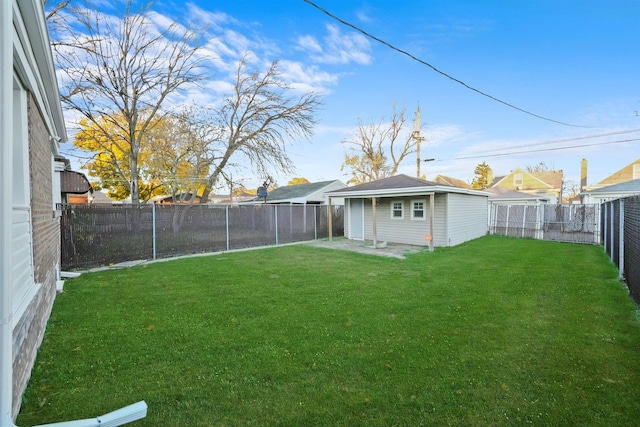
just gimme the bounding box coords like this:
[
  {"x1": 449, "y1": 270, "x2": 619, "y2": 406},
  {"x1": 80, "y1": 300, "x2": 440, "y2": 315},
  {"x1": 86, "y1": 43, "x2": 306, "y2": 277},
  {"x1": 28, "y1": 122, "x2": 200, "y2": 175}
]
[{"x1": 364, "y1": 196, "x2": 441, "y2": 246}]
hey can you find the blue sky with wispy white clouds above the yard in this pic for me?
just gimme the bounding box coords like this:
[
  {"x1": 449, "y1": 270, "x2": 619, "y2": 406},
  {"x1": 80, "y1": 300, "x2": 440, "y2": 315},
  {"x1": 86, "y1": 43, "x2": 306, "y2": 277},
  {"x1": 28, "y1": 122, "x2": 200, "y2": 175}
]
[{"x1": 57, "y1": 0, "x2": 640, "y2": 188}]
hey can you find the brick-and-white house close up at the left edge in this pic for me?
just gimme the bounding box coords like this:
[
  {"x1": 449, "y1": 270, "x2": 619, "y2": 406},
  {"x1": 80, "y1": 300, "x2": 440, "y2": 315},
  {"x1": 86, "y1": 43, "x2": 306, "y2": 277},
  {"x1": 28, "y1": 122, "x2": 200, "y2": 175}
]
[{"x1": 0, "y1": 0, "x2": 66, "y2": 426}]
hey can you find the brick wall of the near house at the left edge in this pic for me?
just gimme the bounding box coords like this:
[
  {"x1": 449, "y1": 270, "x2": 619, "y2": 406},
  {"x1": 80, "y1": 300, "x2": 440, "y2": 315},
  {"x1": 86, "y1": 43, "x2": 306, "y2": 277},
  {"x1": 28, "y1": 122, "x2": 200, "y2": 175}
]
[{"x1": 13, "y1": 94, "x2": 60, "y2": 417}]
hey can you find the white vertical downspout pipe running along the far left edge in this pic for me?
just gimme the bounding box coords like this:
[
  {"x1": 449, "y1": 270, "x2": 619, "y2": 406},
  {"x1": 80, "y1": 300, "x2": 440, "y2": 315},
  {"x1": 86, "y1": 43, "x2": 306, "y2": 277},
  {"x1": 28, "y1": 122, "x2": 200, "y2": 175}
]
[{"x1": 0, "y1": 1, "x2": 14, "y2": 427}]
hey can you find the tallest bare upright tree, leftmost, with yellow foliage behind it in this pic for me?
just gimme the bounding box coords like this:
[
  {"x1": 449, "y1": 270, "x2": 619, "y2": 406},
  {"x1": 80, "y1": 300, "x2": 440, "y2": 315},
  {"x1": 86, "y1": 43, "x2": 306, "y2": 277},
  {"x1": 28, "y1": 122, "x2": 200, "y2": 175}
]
[{"x1": 53, "y1": 0, "x2": 208, "y2": 203}]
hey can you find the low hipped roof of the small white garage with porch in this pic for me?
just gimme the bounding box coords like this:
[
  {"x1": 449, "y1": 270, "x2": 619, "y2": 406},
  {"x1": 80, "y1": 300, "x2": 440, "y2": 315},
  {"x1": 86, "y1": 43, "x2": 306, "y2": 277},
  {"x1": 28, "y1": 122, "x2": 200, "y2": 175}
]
[{"x1": 328, "y1": 174, "x2": 489, "y2": 198}]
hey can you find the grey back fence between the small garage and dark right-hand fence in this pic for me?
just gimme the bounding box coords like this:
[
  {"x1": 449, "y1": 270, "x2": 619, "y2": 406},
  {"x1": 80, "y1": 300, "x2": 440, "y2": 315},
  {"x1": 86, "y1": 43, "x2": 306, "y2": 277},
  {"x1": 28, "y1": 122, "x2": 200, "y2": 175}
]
[{"x1": 489, "y1": 204, "x2": 600, "y2": 244}]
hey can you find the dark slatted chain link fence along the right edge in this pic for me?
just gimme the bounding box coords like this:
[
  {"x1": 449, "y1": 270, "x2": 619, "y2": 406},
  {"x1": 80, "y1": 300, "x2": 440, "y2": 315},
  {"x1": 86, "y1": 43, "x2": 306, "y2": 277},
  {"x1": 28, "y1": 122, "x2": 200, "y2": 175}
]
[{"x1": 600, "y1": 196, "x2": 640, "y2": 304}]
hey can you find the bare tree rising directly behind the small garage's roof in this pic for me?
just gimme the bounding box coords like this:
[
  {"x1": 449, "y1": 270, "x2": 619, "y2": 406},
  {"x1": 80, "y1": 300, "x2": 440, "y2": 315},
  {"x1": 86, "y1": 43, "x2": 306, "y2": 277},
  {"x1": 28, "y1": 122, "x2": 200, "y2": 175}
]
[{"x1": 341, "y1": 104, "x2": 417, "y2": 184}]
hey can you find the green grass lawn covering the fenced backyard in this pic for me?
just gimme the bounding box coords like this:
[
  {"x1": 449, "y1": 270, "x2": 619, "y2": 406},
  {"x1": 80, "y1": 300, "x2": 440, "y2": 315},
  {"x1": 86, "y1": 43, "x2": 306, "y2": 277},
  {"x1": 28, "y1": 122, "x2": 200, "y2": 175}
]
[{"x1": 18, "y1": 236, "x2": 640, "y2": 426}]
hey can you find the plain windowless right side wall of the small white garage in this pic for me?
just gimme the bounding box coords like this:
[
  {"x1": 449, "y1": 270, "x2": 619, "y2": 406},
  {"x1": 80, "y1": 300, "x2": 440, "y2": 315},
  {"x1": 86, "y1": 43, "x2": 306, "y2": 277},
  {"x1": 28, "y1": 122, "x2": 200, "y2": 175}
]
[{"x1": 445, "y1": 193, "x2": 488, "y2": 246}]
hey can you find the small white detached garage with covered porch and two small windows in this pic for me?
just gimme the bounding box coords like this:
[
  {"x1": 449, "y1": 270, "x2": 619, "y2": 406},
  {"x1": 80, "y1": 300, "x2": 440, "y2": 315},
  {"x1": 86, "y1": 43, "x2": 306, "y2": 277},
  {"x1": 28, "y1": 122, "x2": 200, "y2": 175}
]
[{"x1": 329, "y1": 175, "x2": 489, "y2": 248}]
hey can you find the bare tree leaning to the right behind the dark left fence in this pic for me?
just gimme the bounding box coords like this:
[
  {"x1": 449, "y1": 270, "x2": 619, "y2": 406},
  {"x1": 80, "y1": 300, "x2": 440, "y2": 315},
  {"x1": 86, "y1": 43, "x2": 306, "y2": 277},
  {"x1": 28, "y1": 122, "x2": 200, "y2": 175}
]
[{"x1": 195, "y1": 54, "x2": 321, "y2": 203}]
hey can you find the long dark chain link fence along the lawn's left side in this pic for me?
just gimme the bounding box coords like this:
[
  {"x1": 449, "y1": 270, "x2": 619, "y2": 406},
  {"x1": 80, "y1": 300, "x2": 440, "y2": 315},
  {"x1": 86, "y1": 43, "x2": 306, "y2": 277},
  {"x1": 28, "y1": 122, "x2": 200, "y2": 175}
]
[{"x1": 61, "y1": 204, "x2": 344, "y2": 270}]
